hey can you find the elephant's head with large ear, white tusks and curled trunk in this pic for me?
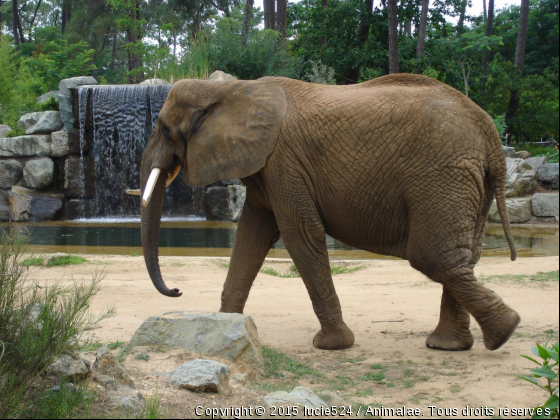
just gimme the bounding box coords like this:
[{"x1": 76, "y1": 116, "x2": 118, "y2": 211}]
[{"x1": 140, "y1": 79, "x2": 287, "y2": 297}]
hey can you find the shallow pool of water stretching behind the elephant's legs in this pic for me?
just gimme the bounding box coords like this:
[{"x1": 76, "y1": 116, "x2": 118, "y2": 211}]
[{"x1": 0, "y1": 219, "x2": 559, "y2": 259}]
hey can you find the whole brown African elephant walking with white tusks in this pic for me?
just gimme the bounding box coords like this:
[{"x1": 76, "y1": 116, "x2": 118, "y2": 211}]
[{"x1": 140, "y1": 74, "x2": 520, "y2": 350}]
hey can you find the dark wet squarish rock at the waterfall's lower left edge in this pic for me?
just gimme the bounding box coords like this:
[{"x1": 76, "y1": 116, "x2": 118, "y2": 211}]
[{"x1": 63, "y1": 156, "x2": 95, "y2": 198}]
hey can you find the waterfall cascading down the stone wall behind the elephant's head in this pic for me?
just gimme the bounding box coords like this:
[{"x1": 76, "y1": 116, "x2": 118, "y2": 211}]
[{"x1": 78, "y1": 85, "x2": 204, "y2": 218}]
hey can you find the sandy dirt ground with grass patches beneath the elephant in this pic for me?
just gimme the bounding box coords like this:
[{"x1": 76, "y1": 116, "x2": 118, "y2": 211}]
[{"x1": 24, "y1": 255, "x2": 559, "y2": 418}]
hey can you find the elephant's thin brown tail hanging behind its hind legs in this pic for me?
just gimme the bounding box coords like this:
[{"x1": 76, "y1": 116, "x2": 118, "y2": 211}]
[{"x1": 489, "y1": 145, "x2": 517, "y2": 261}]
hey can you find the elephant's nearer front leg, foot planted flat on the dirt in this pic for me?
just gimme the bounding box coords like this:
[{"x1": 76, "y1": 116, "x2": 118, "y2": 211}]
[{"x1": 278, "y1": 208, "x2": 354, "y2": 350}]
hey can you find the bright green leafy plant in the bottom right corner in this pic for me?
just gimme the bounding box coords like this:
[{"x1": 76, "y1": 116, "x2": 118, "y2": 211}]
[{"x1": 520, "y1": 343, "x2": 559, "y2": 419}]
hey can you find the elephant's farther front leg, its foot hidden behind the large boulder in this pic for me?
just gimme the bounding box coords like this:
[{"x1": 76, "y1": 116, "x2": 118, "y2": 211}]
[{"x1": 220, "y1": 201, "x2": 280, "y2": 313}]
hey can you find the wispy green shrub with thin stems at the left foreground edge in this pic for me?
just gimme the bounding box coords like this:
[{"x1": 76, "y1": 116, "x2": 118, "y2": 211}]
[{"x1": 0, "y1": 231, "x2": 113, "y2": 418}]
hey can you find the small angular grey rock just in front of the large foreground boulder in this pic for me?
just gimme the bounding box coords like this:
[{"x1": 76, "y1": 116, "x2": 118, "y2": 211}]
[{"x1": 168, "y1": 359, "x2": 229, "y2": 394}]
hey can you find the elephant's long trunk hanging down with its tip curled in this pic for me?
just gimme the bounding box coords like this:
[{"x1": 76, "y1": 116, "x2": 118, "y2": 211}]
[{"x1": 141, "y1": 169, "x2": 182, "y2": 297}]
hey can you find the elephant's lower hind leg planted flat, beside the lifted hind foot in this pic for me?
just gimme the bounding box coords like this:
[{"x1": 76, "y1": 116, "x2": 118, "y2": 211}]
[{"x1": 426, "y1": 286, "x2": 474, "y2": 350}]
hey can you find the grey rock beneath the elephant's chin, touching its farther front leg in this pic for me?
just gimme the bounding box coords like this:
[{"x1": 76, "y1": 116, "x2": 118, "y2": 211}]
[{"x1": 204, "y1": 185, "x2": 246, "y2": 222}]
